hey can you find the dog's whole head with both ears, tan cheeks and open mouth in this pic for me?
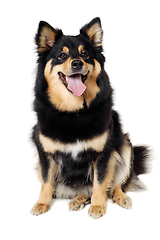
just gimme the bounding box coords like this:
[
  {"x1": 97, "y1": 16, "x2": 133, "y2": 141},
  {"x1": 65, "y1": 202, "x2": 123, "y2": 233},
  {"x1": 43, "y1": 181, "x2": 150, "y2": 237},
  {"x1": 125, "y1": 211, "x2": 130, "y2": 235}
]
[{"x1": 36, "y1": 18, "x2": 104, "y2": 111}]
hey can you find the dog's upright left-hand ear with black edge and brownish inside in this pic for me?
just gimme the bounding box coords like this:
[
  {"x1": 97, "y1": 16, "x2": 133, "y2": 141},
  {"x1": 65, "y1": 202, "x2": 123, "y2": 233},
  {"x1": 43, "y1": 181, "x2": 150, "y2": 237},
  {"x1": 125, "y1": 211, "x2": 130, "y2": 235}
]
[{"x1": 35, "y1": 21, "x2": 63, "y2": 53}]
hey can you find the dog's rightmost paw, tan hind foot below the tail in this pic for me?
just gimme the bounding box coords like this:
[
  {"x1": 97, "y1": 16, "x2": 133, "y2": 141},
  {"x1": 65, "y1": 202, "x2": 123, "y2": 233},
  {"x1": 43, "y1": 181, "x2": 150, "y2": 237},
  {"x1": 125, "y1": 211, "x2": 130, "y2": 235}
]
[{"x1": 113, "y1": 193, "x2": 132, "y2": 209}]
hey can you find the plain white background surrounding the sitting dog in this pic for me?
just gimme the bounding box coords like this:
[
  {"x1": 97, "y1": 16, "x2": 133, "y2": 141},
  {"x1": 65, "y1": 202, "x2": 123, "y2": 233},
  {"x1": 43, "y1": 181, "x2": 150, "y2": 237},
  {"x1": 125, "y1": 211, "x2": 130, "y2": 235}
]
[{"x1": 0, "y1": 0, "x2": 160, "y2": 240}]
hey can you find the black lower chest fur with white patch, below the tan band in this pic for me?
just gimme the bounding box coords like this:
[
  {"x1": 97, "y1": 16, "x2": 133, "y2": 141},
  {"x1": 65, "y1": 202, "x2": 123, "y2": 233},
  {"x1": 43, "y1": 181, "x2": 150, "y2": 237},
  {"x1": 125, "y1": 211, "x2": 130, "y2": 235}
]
[{"x1": 53, "y1": 146, "x2": 99, "y2": 188}]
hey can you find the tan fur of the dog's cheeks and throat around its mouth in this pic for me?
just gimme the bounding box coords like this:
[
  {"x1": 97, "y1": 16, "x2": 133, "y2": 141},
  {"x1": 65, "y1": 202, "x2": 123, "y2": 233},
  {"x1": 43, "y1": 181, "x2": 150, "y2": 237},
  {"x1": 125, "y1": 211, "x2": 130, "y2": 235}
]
[{"x1": 44, "y1": 58, "x2": 101, "y2": 111}]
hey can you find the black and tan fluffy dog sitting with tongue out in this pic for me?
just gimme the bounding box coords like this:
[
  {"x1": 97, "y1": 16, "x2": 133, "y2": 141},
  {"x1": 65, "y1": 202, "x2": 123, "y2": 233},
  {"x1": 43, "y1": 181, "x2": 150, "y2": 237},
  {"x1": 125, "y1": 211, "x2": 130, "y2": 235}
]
[{"x1": 32, "y1": 17, "x2": 148, "y2": 219}]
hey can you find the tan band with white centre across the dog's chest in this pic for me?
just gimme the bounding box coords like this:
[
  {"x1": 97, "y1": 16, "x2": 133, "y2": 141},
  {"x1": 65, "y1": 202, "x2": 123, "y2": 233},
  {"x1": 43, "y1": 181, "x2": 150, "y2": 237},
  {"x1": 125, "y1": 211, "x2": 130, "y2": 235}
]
[{"x1": 39, "y1": 131, "x2": 109, "y2": 158}]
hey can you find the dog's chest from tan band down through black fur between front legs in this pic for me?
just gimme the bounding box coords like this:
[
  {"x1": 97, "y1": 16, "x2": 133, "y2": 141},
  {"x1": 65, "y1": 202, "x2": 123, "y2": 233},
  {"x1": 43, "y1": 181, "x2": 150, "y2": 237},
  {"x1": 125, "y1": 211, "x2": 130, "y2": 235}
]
[{"x1": 39, "y1": 132, "x2": 108, "y2": 188}]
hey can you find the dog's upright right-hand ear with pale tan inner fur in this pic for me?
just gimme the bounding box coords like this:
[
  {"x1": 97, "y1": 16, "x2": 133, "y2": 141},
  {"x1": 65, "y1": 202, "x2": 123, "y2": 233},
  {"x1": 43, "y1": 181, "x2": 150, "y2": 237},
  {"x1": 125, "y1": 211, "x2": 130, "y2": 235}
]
[{"x1": 80, "y1": 17, "x2": 103, "y2": 49}]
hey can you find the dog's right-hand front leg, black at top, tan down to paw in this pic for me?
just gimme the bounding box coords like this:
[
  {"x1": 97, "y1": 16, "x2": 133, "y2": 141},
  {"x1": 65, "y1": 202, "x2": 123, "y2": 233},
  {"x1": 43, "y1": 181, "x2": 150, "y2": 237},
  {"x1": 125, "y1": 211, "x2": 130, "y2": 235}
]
[{"x1": 89, "y1": 151, "x2": 116, "y2": 218}]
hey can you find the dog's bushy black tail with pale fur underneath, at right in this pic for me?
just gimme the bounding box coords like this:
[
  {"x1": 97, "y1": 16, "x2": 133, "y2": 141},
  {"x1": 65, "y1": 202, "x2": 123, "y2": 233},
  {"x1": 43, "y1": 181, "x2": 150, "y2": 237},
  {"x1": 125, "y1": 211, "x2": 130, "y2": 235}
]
[{"x1": 122, "y1": 146, "x2": 151, "y2": 192}]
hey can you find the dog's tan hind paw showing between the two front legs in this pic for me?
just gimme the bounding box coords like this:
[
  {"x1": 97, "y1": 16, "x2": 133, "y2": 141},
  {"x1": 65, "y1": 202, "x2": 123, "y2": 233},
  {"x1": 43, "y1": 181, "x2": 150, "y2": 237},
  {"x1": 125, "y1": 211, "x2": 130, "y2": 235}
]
[{"x1": 69, "y1": 196, "x2": 90, "y2": 211}]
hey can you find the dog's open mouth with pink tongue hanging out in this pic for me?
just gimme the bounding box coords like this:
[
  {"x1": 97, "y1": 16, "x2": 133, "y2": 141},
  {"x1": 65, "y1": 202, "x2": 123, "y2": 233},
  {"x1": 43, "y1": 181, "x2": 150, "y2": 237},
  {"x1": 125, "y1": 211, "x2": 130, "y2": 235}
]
[{"x1": 58, "y1": 72, "x2": 87, "y2": 96}]
